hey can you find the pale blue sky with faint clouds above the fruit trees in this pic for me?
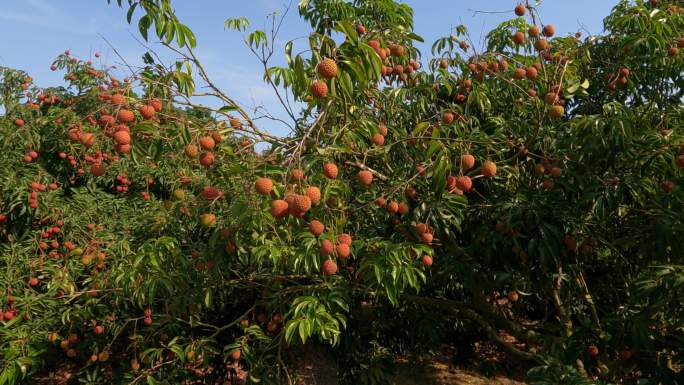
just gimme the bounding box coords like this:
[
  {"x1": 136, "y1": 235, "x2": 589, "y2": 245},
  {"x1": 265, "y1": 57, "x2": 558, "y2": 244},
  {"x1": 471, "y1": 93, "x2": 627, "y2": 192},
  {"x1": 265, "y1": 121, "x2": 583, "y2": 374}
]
[{"x1": 0, "y1": 0, "x2": 617, "y2": 135}]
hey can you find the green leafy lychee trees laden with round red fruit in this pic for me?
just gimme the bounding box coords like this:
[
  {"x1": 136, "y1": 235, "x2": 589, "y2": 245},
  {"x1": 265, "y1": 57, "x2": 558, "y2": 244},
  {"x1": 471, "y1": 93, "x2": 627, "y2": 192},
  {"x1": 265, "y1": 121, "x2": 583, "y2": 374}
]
[{"x1": 0, "y1": 0, "x2": 684, "y2": 384}]
